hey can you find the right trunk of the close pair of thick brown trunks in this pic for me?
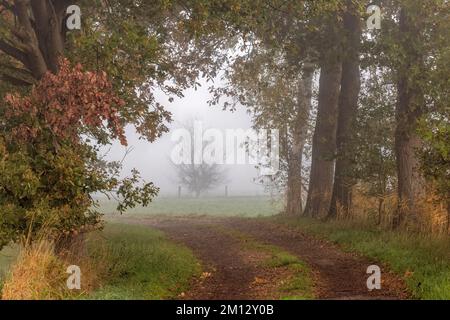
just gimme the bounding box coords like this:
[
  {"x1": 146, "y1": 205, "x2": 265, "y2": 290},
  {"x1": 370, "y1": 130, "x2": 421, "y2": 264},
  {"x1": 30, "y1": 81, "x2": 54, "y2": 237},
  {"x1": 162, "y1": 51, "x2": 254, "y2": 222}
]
[{"x1": 328, "y1": 1, "x2": 362, "y2": 218}]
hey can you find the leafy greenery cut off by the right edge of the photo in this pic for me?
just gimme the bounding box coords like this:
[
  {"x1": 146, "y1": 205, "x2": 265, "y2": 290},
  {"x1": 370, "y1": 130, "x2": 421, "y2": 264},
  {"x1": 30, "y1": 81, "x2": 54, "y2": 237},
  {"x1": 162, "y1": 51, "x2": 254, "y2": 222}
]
[{"x1": 418, "y1": 2, "x2": 450, "y2": 232}]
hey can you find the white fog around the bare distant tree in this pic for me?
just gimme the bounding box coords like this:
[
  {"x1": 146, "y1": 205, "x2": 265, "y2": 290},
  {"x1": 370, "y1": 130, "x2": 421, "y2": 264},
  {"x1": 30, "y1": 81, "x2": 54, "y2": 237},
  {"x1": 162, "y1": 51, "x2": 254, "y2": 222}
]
[{"x1": 103, "y1": 82, "x2": 264, "y2": 196}]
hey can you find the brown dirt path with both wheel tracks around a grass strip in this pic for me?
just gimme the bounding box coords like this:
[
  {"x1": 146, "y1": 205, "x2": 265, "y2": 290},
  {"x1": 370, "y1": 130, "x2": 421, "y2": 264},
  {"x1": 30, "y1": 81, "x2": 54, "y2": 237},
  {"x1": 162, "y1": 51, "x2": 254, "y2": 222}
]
[{"x1": 131, "y1": 217, "x2": 407, "y2": 300}]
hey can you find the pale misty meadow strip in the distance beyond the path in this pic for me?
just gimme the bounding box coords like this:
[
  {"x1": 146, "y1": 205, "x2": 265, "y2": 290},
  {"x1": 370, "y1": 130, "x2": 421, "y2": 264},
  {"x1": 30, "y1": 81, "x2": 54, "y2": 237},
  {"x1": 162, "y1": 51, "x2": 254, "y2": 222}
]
[{"x1": 99, "y1": 197, "x2": 282, "y2": 217}]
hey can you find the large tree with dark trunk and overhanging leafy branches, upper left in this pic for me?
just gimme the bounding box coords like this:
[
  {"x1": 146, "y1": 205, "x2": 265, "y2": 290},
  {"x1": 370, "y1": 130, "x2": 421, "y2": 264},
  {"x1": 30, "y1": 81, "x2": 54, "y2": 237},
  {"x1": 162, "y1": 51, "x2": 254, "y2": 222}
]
[{"x1": 0, "y1": 0, "x2": 221, "y2": 141}]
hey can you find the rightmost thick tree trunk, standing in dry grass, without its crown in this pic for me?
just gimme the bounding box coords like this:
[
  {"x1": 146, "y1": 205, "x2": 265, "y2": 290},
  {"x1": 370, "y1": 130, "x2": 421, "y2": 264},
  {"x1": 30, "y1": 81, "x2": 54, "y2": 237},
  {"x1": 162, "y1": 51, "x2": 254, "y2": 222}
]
[{"x1": 393, "y1": 9, "x2": 425, "y2": 228}]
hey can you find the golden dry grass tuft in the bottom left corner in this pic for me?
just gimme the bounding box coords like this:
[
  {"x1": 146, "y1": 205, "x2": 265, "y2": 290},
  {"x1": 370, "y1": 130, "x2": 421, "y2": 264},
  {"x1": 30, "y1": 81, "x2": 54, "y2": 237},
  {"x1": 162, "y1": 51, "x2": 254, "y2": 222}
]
[{"x1": 1, "y1": 236, "x2": 106, "y2": 300}]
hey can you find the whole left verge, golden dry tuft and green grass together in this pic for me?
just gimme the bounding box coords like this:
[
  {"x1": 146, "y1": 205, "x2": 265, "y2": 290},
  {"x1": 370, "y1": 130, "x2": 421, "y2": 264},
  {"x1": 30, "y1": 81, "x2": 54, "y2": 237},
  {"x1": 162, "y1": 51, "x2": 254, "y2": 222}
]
[{"x1": 0, "y1": 223, "x2": 200, "y2": 300}]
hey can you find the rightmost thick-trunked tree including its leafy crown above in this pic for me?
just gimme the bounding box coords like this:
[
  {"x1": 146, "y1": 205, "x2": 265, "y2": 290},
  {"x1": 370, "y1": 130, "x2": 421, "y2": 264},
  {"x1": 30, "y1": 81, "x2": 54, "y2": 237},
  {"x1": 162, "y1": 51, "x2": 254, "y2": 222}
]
[{"x1": 380, "y1": 0, "x2": 449, "y2": 228}]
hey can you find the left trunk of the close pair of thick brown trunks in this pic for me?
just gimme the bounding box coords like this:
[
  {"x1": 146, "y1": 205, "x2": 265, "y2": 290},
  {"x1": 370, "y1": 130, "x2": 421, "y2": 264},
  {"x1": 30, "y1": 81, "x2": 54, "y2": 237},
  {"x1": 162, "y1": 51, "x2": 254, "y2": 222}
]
[{"x1": 304, "y1": 57, "x2": 342, "y2": 217}]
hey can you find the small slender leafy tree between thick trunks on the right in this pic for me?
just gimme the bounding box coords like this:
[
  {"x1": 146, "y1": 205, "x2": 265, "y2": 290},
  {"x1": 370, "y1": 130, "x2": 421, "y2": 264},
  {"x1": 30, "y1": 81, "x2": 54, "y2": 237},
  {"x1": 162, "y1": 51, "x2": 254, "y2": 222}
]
[{"x1": 354, "y1": 67, "x2": 397, "y2": 224}]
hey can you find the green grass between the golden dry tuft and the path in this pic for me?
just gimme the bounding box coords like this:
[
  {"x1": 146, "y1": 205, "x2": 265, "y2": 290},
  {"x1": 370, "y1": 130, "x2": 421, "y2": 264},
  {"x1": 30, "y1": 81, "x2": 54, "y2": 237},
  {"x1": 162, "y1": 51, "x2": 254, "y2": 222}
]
[{"x1": 88, "y1": 224, "x2": 200, "y2": 300}]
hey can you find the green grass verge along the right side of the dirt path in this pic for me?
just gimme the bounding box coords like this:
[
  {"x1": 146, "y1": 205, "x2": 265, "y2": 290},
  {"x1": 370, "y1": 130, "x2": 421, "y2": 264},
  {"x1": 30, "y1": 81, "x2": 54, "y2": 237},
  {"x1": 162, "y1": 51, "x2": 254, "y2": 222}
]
[{"x1": 276, "y1": 218, "x2": 450, "y2": 300}]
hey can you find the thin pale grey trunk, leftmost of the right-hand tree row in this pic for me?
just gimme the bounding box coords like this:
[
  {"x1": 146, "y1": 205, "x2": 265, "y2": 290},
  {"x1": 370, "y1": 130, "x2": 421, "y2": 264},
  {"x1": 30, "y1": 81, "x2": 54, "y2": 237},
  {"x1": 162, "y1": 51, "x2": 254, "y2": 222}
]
[{"x1": 286, "y1": 62, "x2": 314, "y2": 216}]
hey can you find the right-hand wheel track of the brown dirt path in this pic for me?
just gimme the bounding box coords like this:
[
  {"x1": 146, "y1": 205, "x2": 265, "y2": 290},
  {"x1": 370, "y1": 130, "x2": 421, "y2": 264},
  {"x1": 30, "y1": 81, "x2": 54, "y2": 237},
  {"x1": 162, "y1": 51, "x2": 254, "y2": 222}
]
[{"x1": 223, "y1": 219, "x2": 408, "y2": 300}]
